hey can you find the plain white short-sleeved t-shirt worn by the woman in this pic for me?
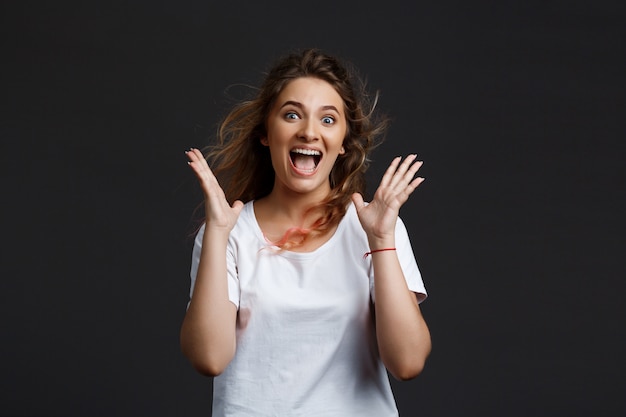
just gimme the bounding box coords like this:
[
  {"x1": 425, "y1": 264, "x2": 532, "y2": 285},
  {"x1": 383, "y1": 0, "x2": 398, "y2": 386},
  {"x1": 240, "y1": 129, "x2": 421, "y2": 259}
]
[{"x1": 191, "y1": 202, "x2": 426, "y2": 417}]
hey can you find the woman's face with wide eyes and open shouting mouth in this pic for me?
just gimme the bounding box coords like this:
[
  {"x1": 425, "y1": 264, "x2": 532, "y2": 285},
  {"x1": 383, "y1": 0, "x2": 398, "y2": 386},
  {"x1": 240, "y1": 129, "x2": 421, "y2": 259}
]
[{"x1": 261, "y1": 77, "x2": 347, "y2": 198}]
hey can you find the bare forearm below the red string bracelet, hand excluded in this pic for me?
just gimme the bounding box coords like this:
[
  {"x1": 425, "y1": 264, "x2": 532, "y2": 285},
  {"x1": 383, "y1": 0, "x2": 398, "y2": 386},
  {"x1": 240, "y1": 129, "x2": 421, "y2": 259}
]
[{"x1": 372, "y1": 247, "x2": 431, "y2": 380}]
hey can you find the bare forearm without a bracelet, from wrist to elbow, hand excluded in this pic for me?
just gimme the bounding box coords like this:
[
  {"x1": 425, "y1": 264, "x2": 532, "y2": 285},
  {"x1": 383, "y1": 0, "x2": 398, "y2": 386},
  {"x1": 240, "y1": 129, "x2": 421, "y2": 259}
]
[{"x1": 180, "y1": 230, "x2": 237, "y2": 376}]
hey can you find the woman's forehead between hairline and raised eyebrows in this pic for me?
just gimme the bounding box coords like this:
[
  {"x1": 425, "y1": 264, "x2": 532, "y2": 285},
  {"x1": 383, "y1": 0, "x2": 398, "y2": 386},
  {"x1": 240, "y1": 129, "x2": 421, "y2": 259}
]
[{"x1": 276, "y1": 77, "x2": 345, "y2": 111}]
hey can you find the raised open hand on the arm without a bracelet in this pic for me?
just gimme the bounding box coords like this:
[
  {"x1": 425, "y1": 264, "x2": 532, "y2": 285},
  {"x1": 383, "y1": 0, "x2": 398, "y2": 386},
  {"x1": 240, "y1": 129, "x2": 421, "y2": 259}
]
[{"x1": 185, "y1": 148, "x2": 243, "y2": 233}]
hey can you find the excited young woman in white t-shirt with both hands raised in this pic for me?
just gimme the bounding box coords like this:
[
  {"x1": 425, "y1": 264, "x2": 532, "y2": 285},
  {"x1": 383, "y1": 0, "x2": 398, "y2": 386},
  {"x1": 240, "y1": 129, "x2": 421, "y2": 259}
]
[{"x1": 181, "y1": 49, "x2": 431, "y2": 417}]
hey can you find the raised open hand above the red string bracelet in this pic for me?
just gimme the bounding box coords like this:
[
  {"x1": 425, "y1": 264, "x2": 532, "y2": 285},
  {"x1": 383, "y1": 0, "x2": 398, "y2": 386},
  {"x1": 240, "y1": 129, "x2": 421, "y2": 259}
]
[{"x1": 352, "y1": 154, "x2": 424, "y2": 245}]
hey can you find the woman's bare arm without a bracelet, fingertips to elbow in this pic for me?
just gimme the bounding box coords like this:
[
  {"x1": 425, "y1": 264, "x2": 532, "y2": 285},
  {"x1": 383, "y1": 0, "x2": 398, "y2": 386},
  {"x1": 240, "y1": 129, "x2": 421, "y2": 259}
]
[{"x1": 180, "y1": 149, "x2": 243, "y2": 376}]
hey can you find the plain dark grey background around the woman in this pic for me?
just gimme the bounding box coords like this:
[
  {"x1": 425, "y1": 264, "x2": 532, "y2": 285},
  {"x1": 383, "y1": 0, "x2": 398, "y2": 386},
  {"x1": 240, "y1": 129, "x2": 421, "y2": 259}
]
[{"x1": 0, "y1": 1, "x2": 626, "y2": 417}]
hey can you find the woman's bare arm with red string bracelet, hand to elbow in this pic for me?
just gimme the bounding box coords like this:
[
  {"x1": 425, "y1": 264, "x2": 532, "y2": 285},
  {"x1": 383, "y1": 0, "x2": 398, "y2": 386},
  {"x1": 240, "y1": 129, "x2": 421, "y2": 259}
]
[{"x1": 352, "y1": 155, "x2": 431, "y2": 380}]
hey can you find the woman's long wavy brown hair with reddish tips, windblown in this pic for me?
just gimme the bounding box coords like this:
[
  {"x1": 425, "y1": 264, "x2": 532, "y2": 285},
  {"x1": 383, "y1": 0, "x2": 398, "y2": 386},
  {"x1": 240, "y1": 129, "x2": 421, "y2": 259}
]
[{"x1": 201, "y1": 48, "x2": 388, "y2": 249}]
